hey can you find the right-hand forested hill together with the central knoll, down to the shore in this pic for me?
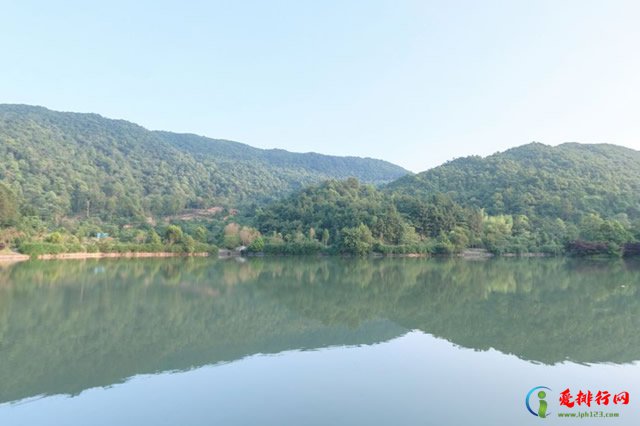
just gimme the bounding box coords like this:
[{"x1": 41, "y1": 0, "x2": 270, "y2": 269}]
[{"x1": 250, "y1": 143, "x2": 640, "y2": 256}]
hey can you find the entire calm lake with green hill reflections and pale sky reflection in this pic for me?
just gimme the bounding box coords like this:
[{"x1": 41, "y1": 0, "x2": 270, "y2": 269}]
[{"x1": 0, "y1": 258, "x2": 640, "y2": 425}]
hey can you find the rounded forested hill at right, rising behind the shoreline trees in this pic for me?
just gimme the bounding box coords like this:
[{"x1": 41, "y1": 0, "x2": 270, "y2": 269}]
[{"x1": 386, "y1": 143, "x2": 640, "y2": 221}]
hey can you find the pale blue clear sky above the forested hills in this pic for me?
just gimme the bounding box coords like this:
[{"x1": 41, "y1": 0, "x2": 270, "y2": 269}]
[{"x1": 0, "y1": 0, "x2": 640, "y2": 172}]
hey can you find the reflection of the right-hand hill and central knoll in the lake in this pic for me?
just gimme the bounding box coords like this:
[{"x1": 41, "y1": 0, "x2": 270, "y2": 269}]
[{"x1": 258, "y1": 259, "x2": 640, "y2": 364}]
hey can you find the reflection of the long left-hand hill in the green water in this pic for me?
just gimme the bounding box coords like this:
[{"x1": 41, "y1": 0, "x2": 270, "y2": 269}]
[{"x1": 0, "y1": 259, "x2": 405, "y2": 402}]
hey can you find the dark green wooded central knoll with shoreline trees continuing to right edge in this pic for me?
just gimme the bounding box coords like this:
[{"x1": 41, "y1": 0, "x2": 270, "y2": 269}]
[{"x1": 250, "y1": 179, "x2": 640, "y2": 256}]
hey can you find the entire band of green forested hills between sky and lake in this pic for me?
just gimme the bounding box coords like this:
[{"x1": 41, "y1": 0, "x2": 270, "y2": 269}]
[{"x1": 0, "y1": 105, "x2": 640, "y2": 256}]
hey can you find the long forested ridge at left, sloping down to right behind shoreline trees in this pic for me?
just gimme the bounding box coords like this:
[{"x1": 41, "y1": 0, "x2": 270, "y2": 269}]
[{"x1": 0, "y1": 105, "x2": 408, "y2": 220}]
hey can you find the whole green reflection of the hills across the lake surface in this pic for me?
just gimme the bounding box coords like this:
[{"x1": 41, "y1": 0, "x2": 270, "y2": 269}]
[{"x1": 0, "y1": 258, "x2": 640, "y2": 402}]
